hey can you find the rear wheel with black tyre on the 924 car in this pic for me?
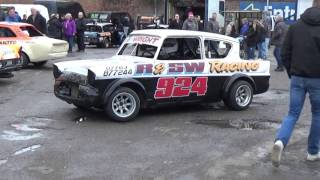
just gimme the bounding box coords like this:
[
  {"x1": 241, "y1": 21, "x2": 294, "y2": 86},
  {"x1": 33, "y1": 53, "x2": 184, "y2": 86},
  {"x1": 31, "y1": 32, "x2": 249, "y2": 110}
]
[{"x1": 224, "y1": 80, "x2": 253, "y2": 111}]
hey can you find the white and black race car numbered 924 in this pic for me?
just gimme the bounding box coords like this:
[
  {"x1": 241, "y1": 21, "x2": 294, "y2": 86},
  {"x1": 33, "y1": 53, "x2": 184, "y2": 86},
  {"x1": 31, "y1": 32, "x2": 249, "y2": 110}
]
[{"x1": 53, "y1": 29, "x2": 270, "y2": 121}]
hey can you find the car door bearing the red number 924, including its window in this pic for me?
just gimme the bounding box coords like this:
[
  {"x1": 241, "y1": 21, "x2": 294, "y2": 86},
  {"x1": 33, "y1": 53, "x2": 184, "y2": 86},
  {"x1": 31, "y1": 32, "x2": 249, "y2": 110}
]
[{"x1": 154, "y1": 36, "x2": 208, "y2": 103}]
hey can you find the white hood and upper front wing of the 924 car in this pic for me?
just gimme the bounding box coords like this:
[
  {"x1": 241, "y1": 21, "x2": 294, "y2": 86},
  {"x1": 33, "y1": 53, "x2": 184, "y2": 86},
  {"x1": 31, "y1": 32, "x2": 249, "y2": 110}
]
[{"x1": 54, "y1": 56, "x2": 153, "y2": 79}]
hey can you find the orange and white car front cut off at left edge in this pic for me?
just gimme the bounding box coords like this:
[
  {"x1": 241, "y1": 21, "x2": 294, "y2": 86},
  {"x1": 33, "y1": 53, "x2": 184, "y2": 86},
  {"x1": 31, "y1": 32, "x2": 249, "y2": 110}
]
[{"x1": 0, "y1": 41, "x2": 21, "y2": 78}]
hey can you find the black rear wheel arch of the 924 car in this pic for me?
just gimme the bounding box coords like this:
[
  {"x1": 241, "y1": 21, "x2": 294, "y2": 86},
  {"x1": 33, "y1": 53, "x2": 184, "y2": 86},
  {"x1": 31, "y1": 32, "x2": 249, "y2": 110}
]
[{"x1": 223, "y1": 74, "x2": 256, "y2": 98}]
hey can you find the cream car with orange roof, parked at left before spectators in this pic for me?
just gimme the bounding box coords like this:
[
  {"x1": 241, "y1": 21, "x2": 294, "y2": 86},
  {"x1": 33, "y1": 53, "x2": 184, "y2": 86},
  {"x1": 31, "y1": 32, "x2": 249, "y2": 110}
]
[{"x1": 0, "y1": 22, "x2": 68, "y2": 67}]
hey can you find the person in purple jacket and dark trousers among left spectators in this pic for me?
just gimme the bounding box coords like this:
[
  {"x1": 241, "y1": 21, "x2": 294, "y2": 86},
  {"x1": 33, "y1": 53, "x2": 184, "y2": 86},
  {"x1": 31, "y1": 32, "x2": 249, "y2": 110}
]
[{"x1": 63, "y1": 13, "x2": 76, "y2": 53}]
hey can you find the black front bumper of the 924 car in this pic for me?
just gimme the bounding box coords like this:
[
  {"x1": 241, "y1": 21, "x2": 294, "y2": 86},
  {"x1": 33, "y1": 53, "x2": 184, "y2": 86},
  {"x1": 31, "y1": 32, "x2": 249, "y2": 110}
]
[{"x1": 54, "y1": 80, "x2": 99, "y2": 107}]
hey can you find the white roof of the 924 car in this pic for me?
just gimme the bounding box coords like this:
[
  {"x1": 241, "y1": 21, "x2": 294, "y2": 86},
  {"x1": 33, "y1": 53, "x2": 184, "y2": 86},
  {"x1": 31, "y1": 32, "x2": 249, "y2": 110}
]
[{"x1": 131, "y1": 29, "x2": 239, "y2": 43}]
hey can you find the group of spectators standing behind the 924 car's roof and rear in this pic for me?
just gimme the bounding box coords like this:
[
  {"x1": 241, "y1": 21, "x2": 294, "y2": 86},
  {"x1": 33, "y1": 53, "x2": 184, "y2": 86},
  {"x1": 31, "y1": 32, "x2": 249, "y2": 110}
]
[{"x1": 169, "y1": 11, "x2": 288, "y2": 71}]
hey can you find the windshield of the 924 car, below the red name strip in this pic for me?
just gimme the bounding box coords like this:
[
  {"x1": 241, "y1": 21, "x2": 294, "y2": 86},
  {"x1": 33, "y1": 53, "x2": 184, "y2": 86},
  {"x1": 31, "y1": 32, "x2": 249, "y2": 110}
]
[{"x1": 118, "y1": 43, "x2": 157, "y2": 59}]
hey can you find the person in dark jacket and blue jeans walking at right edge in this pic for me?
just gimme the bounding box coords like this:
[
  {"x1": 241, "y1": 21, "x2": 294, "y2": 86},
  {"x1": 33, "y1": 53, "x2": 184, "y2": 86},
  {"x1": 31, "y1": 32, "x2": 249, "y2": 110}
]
[{"x1": 271, "y1": 0, "x2": 320, "y2": 167}]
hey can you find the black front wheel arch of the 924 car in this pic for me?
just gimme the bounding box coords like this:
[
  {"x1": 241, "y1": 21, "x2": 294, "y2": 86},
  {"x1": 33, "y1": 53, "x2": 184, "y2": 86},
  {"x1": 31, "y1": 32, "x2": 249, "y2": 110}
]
[{"x1": 103, "y1": 79, "x2": 147, "y2": 107}]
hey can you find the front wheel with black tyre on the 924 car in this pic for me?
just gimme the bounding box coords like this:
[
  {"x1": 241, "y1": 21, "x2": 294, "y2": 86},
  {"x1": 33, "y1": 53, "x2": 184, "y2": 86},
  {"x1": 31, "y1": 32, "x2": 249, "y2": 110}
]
[{"x1": 105, "y1": 87, "x2": 140, "y2": 122}]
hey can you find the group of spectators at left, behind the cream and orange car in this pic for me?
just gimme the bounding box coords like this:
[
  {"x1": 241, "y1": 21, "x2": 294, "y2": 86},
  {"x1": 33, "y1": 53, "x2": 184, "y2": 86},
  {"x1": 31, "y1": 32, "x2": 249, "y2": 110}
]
[{"x1": 0, "y1": 7, "x2": 86, "y2": 53}]
